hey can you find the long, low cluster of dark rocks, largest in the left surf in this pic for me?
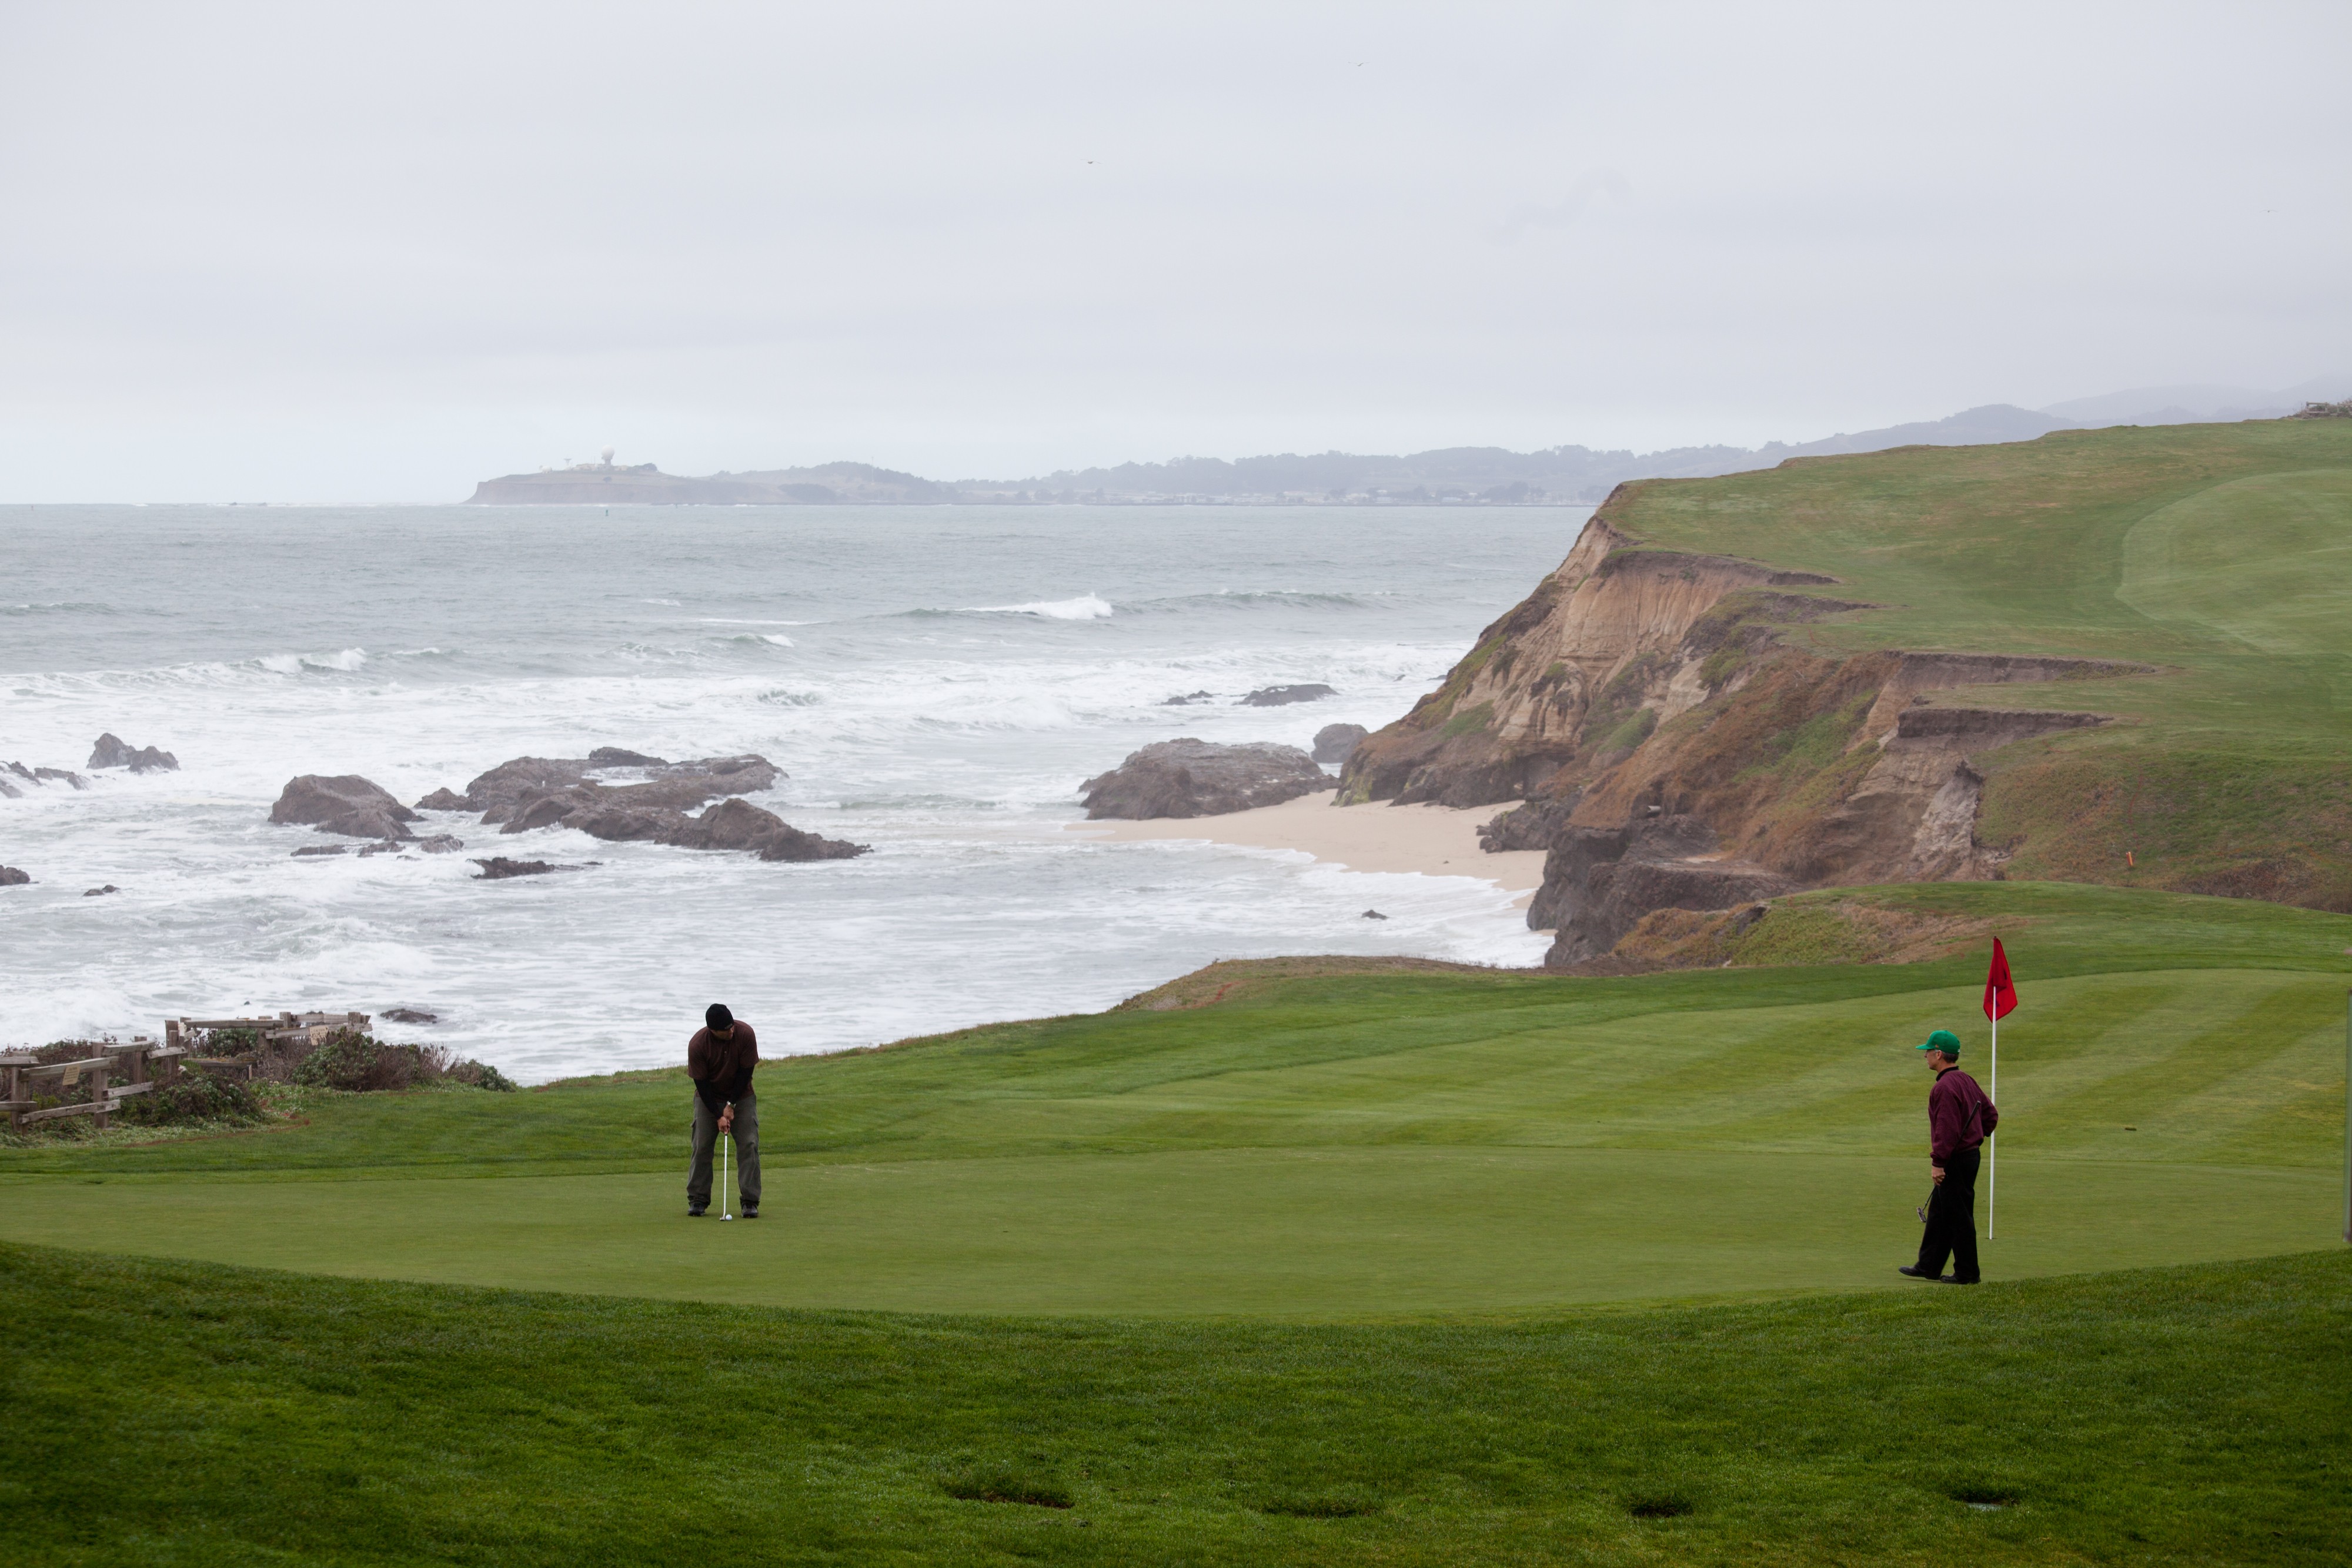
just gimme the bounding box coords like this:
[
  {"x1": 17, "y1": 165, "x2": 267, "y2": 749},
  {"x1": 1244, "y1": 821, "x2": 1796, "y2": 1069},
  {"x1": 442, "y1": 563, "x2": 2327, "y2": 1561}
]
[{"x1": 416, "y1": 745, "x2": 868, "y2": 860}]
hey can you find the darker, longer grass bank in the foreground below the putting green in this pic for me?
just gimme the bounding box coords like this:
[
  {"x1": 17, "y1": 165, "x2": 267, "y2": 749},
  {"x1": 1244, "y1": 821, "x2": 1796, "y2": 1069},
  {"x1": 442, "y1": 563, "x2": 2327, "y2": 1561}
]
[{"x1": 0, "y1": 1246, "x2": 2352, "y2": 1568}]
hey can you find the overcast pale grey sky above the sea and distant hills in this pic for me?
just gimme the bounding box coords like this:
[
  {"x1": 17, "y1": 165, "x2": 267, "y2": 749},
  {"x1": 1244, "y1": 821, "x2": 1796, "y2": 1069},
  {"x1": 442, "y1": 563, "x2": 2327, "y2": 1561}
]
[{"x1": 0, "y1": 0, "x2": 2352, "y2": 501}]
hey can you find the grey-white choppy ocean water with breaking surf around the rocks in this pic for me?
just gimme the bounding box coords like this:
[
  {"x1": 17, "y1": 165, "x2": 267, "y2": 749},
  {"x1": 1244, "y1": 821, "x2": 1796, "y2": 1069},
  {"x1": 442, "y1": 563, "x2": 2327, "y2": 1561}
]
[{"x1": 0, "y1": 506, "x2": 1588, "y2": 1081}]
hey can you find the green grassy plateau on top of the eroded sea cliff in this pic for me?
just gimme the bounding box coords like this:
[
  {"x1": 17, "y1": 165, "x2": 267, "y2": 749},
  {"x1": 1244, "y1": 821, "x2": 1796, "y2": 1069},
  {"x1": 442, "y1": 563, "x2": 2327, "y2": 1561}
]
[{"x1": 1604, "y1": 421, "x2": 2352, "y2": 757}]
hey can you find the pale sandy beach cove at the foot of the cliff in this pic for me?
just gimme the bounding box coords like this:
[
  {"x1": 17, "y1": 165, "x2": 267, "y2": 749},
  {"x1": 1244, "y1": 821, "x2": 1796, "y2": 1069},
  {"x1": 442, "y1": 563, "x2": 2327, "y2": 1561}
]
[{"x1": 1063, "y1": 794, "x2": 1543, "y2": 905}]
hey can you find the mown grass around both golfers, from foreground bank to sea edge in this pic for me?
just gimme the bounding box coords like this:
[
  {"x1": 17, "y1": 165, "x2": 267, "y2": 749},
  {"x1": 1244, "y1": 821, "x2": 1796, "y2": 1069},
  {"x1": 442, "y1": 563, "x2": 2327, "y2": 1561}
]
[{"x1": 0, "y1": 884, "x2": 2352, "y2": 1319}]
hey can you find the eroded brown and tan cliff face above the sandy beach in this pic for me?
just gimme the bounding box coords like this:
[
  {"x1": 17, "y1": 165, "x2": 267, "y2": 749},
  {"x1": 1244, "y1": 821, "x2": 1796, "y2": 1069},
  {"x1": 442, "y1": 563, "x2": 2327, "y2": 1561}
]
[{"x1": 1341, "y1": 508, "x2": 2145, "y2": 966}]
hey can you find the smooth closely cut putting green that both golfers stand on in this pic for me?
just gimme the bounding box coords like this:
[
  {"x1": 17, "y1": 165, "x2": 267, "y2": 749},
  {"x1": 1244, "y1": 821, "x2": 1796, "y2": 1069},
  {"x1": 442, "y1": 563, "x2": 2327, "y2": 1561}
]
[{"x1": 0, "y1": 1147, "x2": 2336, "y2": 1319}]
